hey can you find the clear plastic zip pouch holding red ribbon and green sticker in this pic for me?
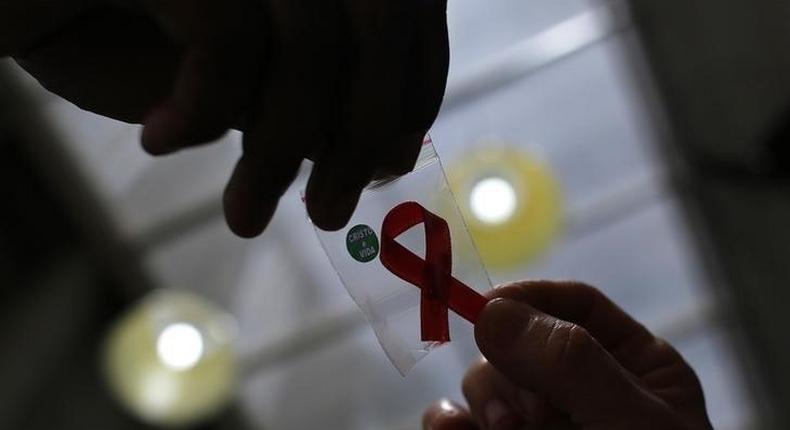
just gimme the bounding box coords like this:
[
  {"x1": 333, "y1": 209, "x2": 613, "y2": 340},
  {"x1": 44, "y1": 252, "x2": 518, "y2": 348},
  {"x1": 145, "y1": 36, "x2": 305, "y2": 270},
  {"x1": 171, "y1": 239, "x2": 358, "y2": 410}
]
[{"x1": 308, "y1": 138, "x2": 491, "y2": 375}]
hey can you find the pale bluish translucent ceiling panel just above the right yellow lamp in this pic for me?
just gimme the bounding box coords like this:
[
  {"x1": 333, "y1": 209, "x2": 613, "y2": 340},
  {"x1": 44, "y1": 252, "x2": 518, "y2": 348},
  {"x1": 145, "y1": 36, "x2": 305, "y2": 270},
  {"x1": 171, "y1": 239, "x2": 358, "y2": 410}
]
[{"x1": 432, "y1": 37, "x2": 656, "y2": 210}]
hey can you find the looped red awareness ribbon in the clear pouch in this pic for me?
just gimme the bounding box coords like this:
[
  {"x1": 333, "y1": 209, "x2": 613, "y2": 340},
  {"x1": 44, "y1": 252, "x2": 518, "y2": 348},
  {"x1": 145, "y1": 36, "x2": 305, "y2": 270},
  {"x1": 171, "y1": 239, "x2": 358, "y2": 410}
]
[{"x1": 381, "y1": 202, "x2": 487, "y2": 342}]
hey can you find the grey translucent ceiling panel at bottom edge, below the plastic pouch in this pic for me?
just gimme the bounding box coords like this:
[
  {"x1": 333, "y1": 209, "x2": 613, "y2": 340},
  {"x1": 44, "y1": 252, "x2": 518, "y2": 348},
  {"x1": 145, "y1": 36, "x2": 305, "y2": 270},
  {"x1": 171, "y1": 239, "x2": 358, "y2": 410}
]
[{"x1": 242, "y1": 327, "x2": 475, "y2": 430}]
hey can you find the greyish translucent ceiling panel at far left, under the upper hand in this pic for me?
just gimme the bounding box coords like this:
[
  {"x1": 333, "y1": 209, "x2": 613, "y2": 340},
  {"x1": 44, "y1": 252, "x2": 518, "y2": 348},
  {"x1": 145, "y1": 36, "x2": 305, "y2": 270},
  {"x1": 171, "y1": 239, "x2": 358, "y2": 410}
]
[{"x1": 44, "y1": 95, "x2": 240, "y2": 236}]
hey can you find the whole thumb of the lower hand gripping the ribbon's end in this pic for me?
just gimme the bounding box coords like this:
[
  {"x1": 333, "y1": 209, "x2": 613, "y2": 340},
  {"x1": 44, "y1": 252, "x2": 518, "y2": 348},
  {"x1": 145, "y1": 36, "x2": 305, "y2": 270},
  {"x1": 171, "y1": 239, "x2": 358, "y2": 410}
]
[{"x1": 475, "y1": 299, "x2": 655, "y2": 428}]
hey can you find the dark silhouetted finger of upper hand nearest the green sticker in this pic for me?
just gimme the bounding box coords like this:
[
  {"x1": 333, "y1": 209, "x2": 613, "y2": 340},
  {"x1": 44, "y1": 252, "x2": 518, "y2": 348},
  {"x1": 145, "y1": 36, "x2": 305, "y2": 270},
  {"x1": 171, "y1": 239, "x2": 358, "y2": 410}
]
[{"x1": 306, "y1": 0, "x2": 422, "y2": 230}]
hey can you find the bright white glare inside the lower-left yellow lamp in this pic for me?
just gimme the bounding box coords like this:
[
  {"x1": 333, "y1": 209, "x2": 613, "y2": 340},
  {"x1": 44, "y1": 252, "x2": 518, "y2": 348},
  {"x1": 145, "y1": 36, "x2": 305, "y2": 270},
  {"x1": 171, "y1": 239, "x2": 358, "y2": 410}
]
[{"x1": 156, "y1": 323, "x2": 203, "y2": 370}]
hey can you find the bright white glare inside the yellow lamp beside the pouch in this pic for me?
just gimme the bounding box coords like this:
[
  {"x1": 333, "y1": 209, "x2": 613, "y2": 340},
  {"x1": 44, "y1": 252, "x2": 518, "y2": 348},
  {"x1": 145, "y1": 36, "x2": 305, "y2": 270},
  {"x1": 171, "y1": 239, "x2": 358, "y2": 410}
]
[{"x1": 469, "y1": 178, "x2": 518, "y2": 224}]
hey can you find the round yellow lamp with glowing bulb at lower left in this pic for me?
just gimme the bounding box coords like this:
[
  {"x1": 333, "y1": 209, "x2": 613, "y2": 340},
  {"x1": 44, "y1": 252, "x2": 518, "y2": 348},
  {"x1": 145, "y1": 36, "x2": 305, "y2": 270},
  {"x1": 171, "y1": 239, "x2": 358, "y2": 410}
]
[{"x1": 103, "y1": 291, "x2": 236, "y2": 427}]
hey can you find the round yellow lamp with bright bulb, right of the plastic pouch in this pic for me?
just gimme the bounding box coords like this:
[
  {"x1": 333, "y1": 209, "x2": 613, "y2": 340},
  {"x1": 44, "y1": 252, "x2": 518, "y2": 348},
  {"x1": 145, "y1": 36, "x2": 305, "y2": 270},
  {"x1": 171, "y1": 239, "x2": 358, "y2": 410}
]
[{"x1": 447, "y1": 144, "x2": 562, "y2": 270}]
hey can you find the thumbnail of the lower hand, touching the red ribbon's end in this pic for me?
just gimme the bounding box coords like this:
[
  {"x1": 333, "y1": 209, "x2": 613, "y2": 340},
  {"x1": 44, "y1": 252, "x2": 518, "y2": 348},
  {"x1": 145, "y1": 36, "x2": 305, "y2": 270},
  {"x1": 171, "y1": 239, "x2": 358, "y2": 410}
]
[{"x1": 475, "y1": 299, "x2": 532, "y2": 353}]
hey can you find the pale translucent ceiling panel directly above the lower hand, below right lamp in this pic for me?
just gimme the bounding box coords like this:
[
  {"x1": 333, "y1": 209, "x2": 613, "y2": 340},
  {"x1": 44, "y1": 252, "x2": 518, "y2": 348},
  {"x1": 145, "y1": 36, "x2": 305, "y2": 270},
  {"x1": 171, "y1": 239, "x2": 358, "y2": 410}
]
[{"x1": 524, "y1": 200, "x2": 708, "y2": 328}]
